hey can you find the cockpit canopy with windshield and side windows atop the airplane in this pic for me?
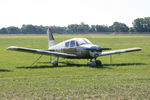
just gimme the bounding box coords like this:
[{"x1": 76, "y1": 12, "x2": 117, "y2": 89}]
[{"x1": 65, "y1": 38, "x2": 92, "y2": 47}]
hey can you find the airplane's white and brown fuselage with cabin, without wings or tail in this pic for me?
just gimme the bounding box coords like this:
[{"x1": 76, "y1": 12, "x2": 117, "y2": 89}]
[{"x1": 48, "y1": 38, "x2": 101, "y2": 59}]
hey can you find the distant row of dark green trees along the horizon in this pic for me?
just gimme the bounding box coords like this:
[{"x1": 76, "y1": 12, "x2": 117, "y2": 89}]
[{"x1": 0, "y1": 17, "x2": 150, "y2": 34}]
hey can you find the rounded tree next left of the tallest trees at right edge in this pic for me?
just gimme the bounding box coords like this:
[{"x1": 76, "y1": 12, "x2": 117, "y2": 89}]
[{"x1": 110, "y1": 22, "x2": 129, "y2": 32}]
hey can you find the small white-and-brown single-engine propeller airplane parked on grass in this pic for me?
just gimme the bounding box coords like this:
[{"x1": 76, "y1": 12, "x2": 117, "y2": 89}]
[{"x1": 7, "y1": 28, "x2": 142, "y2": 66}]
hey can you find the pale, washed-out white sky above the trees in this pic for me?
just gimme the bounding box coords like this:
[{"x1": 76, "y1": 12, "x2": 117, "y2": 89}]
[{"x1": 0, "y1": 0, "x2": 150, "y2": 28}]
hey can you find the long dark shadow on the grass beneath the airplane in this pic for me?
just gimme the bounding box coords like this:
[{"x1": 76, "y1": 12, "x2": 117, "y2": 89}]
[{"x1": 16, "y1": 63, "x2": 146, "y2": 69}]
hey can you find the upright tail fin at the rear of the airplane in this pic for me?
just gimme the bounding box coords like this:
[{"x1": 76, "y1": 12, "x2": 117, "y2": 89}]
[{"x1": 47, "y1": 28, "x2": 56, "y2": 48}]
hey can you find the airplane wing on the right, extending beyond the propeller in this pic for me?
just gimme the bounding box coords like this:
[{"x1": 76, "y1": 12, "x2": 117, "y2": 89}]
[{"x1": 100, "y1": 48, "x2": 142, "y2": 56}]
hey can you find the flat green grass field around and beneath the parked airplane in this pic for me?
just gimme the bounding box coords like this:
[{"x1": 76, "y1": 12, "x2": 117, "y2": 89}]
[{"x1": 0, "y1": 35, "x2": 150, "y2": 100}]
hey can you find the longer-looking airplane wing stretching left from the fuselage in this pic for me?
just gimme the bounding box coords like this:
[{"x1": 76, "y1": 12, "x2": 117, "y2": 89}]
[{"x1": 7, "y1": 46, "x2": 76, "y2": 57}]
